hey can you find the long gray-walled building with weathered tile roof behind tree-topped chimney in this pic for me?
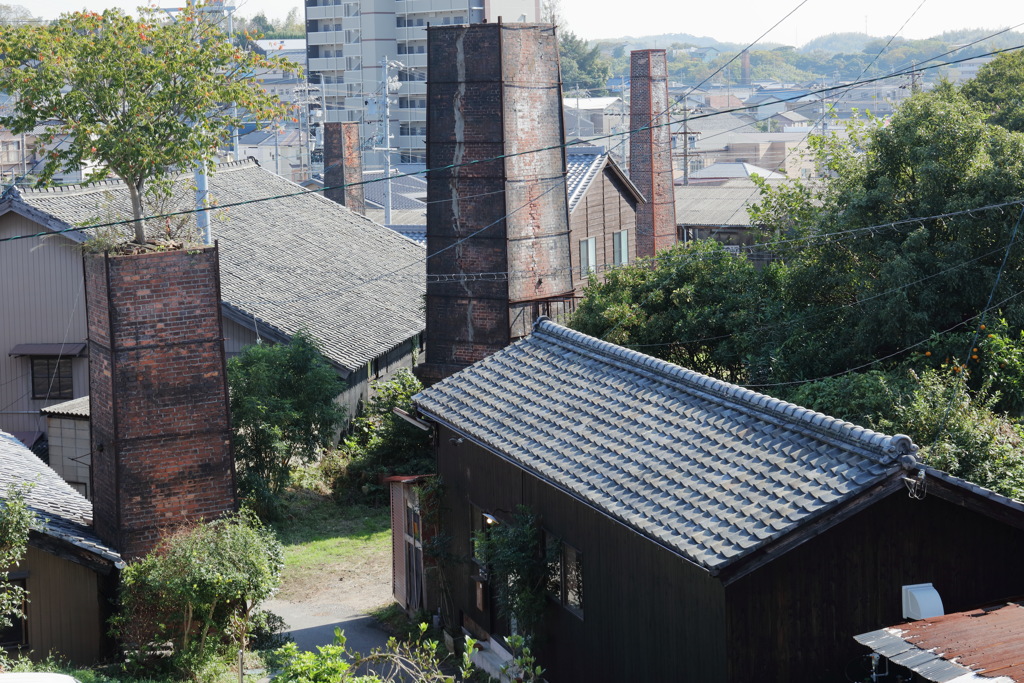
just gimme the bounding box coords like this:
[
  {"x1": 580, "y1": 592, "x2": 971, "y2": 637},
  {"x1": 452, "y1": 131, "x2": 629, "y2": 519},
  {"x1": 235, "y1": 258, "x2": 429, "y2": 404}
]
[{"x1": 0, "y1": 161, "x2": 426, "y2": 442}]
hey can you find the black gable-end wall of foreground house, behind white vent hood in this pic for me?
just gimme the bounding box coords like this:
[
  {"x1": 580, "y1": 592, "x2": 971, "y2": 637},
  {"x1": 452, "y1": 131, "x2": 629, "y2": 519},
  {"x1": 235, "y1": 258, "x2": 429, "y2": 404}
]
[{"x1": 726, "y1": 490, "x2": 1024, "y2": 683}]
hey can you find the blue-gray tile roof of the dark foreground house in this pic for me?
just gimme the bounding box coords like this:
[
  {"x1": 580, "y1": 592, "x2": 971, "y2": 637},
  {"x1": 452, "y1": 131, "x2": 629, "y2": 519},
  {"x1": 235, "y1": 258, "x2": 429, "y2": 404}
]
[{"x1": 414, "y1": 318, "x2": 913, "y2": 571}]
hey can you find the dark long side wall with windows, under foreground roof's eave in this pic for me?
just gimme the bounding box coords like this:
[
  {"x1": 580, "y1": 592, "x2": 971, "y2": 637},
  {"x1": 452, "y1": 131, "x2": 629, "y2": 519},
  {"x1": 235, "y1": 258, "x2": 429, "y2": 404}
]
[{"x1": 438, "y1": 429, "x2": 726, "y2": 683}]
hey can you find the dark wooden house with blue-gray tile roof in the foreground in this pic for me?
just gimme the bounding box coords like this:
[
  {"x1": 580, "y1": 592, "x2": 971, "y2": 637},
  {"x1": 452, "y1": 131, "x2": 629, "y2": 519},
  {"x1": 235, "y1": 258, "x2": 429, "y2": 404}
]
[{"x1": 414, "y1": 318, "x2": 1024, "y2": 683}]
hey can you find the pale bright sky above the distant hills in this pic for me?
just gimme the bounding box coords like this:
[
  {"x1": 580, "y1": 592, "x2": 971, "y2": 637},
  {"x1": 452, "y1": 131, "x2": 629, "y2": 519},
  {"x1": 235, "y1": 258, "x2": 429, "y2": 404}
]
[{"x1": 25, "y1": 0, "x2": 1024, "y2": 47}]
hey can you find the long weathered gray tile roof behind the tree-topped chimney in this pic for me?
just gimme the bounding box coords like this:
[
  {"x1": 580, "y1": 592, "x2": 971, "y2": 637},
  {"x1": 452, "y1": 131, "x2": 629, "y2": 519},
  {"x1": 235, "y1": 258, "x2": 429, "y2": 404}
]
[{"x1": 15, "y1": 162, "x2": 426, "y2": 372}]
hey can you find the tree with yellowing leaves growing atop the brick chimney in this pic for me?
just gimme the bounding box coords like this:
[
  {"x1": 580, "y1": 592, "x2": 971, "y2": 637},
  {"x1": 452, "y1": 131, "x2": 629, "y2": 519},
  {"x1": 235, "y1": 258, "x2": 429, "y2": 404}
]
[{"x1": 0, "y1": 3, "x2": 294, "y2": 244}]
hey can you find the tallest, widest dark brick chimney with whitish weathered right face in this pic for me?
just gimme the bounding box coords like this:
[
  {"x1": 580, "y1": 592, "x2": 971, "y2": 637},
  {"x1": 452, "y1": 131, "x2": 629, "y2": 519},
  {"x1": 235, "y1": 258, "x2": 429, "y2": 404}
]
[{"x1": 421, "y1": 24, "x2": 572, "y2": 383}]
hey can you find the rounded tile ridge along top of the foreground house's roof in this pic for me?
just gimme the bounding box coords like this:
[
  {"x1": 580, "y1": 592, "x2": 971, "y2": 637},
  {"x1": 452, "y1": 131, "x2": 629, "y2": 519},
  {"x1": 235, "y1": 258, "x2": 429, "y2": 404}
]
[{"x1": 534, "y1": 316, "x2": 918, "y2": 465}]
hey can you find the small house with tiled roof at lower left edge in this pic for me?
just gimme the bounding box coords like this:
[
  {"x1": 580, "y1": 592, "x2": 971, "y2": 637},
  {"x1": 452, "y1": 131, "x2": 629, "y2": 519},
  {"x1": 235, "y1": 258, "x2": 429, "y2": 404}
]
[{"x1": 0, "y1": 431, "x2": 124, "y2": 665}]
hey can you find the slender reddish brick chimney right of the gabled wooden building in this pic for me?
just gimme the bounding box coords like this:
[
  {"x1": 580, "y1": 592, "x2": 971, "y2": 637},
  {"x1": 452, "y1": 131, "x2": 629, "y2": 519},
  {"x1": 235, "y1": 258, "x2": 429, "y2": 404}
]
[{"x1": 630, "y1": 50, "x2": 676, "y2": 256}]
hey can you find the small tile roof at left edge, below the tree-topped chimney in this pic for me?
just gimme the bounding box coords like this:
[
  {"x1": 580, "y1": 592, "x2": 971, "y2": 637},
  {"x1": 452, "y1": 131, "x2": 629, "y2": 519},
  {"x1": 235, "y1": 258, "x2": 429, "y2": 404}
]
[{"x1": 0, "y1": 431, "x2": 122, "y2": 565}]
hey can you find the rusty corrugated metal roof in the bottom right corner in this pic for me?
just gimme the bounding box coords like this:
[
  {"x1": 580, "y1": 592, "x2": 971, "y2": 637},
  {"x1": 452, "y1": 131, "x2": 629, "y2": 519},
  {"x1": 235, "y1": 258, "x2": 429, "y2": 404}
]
[{"x1": 856, "y1": 602, "x2": 1024, "y2": 683}]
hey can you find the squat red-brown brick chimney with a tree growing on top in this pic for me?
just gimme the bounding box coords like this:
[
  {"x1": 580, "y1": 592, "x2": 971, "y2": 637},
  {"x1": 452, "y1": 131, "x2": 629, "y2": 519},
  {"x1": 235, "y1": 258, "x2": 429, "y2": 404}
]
[{"x1": 85, "y1": 247, "x2": 236, "y2": 557}]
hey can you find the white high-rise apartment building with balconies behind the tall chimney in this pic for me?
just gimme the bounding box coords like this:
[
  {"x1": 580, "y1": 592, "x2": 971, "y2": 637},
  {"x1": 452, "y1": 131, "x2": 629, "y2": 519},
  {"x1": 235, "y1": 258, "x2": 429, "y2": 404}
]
[{"x1": 305, "y1": 0, "x2": 541, "y2": 167}]
